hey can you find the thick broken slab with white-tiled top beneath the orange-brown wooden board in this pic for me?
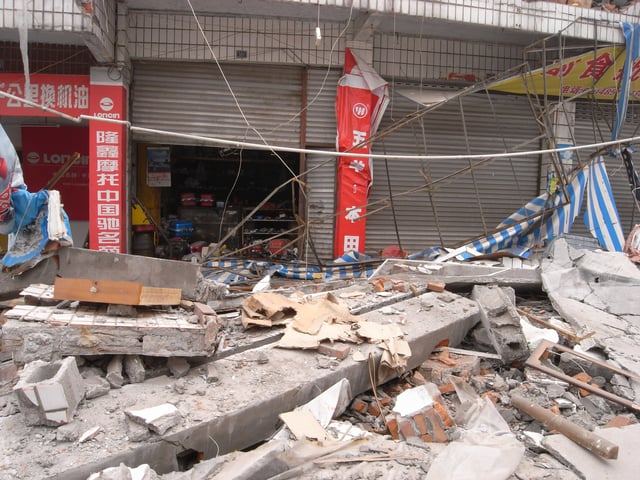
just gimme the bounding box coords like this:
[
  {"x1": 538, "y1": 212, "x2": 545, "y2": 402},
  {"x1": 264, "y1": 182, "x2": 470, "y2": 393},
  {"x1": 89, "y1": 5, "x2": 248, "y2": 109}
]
[{"x1": 2, "y1": 304, "x2": 219, "y2": 365}]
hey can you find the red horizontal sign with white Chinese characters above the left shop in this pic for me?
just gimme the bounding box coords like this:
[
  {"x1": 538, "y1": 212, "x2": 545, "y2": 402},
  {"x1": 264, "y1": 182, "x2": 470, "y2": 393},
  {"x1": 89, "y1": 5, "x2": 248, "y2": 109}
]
[{"x1": 0, "y1": 73, "x2": 89, "y2": 117}]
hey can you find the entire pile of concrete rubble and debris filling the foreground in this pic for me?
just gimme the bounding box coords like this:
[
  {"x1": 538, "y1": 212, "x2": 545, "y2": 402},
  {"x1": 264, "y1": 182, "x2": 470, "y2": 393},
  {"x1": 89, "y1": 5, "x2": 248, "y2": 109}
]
[{"x1": 0, "y1": 237, "x2": 640, "y2": 480}]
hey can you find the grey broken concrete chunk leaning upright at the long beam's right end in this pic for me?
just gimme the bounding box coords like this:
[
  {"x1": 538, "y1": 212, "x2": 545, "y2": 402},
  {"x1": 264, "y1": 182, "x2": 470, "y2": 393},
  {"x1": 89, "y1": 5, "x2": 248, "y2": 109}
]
[{"x1": 471, "y1": 285, "x2": 529, "y2": 364}]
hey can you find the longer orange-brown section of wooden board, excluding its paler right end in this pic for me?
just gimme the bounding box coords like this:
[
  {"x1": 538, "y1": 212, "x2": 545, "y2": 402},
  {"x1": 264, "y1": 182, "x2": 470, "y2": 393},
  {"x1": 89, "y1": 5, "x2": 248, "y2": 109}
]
[{"x1": 53, "y1": 278, "x2": 142, "y2": 305}]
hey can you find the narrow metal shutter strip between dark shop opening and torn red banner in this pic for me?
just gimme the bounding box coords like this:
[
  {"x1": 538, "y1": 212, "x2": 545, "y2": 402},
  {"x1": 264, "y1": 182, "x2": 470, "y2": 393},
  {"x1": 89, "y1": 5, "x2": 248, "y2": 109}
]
[{"x1": 306, "y1": 68, "x2": 341, "y2": 261}]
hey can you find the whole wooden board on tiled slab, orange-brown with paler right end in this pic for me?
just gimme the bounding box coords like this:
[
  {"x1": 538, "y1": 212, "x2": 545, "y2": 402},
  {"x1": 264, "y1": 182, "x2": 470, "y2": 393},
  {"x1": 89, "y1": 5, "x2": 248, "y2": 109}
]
[{"x1": 53, "y1": 278, "x2": 182, "y2": 305}]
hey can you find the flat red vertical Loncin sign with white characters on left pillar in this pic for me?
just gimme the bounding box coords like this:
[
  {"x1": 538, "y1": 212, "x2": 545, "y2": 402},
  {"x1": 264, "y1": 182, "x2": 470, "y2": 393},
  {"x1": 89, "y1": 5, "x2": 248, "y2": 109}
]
[{"x1": 89, "y1": 67, "x2": 127, "y2": 253}]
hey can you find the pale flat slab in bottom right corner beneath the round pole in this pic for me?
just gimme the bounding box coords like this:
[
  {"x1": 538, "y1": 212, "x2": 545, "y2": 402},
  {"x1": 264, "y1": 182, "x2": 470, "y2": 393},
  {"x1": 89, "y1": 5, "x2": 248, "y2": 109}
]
[{"x1": 543, "y1": 424, "x2": 640, "y2": 480}]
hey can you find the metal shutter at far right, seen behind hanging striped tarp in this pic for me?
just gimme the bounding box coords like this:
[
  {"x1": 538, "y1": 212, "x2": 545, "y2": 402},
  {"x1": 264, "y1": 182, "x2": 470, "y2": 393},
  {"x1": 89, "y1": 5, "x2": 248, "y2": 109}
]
[{"x1": 571, "y1": 102, "x2": 640, "y2": 237}]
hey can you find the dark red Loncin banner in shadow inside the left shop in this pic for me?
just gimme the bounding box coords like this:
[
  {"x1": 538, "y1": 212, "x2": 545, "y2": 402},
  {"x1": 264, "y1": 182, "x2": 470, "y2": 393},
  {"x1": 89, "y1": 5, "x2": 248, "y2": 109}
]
[{"x1": 22, "y1": 125, "x2": 89, "y2": 221}]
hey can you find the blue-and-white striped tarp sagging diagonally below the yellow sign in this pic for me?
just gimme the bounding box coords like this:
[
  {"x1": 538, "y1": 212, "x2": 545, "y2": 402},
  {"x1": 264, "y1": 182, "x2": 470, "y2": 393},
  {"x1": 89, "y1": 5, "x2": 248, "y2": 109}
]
[{"x1": 456, "y1": 157, "x2": 624, "y2": 260}]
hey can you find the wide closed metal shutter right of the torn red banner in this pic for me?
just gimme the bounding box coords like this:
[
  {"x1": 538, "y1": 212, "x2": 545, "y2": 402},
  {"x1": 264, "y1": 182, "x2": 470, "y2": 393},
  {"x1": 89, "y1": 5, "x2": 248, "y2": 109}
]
[{"x1": 366, "y1": 90, "x2": 539, "y2": 253}]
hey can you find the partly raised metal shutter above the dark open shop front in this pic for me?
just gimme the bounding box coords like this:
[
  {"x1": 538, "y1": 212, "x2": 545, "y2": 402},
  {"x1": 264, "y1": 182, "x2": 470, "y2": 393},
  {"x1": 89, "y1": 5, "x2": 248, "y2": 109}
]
[{"x1": 131, "y1": 62, "x2": 303, "y2": 147}]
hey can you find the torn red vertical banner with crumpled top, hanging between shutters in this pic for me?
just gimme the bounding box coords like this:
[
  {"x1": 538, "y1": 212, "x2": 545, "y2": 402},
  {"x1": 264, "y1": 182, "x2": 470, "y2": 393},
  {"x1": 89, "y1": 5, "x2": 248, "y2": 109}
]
[{"x1": 334, "y1": 48, "x2": 389, "y2": 256}]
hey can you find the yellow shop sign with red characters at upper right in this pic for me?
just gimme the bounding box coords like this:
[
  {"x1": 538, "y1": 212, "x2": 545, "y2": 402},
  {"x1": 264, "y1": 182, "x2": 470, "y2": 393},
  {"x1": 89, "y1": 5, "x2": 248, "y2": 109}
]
[{"x1": 489, "y1": 46, "x2": 640, "y2": 101}]
